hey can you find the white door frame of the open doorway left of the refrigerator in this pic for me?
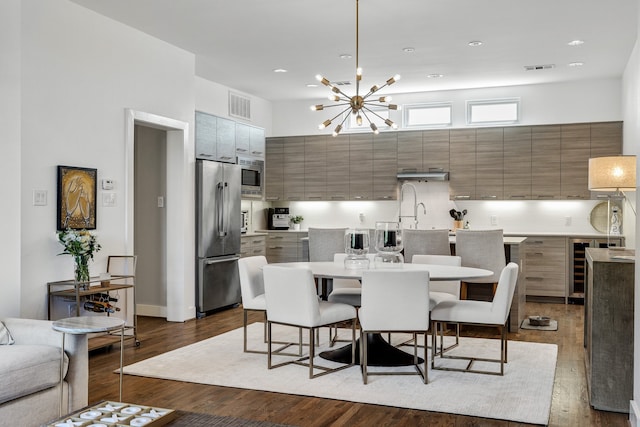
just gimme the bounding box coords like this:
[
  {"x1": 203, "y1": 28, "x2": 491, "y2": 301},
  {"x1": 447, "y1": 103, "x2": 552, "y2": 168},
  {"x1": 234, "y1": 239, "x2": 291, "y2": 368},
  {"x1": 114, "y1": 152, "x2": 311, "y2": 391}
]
[{"x1": 124, "y1": 108, "x2": 195, "y2": 322}]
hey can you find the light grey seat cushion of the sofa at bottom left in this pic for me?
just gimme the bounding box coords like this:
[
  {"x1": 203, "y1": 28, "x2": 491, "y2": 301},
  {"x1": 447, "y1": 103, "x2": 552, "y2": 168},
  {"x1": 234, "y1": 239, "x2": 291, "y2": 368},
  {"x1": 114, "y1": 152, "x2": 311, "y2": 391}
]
[{"x1": 0, "y1": 344, "x2": 69, "y2": 404}]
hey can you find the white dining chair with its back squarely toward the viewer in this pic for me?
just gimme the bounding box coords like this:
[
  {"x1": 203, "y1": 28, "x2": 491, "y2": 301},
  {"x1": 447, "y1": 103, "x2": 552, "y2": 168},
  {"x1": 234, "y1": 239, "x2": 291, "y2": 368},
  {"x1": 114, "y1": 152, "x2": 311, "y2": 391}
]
[{"x1": 358, "y1": 269, "x2": 429, "y2": 384}]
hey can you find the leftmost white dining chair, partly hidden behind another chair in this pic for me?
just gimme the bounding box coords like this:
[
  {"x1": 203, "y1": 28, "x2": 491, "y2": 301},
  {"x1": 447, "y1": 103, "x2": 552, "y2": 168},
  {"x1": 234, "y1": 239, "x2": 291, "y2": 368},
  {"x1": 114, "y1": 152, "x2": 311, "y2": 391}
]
[{"x1": 238, "y1": 255, "x2": 302, "y2": 356}]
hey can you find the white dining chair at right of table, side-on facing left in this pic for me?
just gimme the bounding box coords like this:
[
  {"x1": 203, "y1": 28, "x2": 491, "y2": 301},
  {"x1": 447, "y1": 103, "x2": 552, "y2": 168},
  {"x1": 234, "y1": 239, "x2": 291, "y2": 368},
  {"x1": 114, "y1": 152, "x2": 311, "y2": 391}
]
[{"x1": 431, "y1": 262, "x2": 519, "y2": 375}]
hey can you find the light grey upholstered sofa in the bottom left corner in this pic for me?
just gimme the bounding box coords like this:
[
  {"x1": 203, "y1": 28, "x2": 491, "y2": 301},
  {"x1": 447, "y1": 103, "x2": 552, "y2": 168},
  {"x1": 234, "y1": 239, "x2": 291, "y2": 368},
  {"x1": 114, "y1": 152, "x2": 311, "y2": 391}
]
[{"x1": 0, "y1": 318, "x2": 89, "y2": 427}]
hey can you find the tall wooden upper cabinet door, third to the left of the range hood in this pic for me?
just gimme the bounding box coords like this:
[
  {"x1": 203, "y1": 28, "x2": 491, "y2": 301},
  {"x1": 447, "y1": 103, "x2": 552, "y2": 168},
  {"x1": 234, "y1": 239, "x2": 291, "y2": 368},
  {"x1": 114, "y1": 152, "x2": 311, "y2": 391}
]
[{"x1": 326, "y1": 135, "x2": 349, "y2": 200}]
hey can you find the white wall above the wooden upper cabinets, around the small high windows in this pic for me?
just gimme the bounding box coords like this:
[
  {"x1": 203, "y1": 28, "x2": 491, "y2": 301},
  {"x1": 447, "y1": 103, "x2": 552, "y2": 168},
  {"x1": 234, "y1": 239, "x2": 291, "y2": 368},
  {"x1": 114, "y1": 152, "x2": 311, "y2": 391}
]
[{"x1": 273, "y1": 78, "x2": 622, "y2": 136}]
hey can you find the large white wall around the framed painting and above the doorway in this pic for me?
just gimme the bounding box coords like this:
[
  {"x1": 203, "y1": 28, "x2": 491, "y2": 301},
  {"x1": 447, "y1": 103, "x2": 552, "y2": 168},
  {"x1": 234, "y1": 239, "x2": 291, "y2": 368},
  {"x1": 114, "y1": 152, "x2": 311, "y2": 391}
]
[{"x1": 18, "y1": 0, "x2": 195, "y2": 318}]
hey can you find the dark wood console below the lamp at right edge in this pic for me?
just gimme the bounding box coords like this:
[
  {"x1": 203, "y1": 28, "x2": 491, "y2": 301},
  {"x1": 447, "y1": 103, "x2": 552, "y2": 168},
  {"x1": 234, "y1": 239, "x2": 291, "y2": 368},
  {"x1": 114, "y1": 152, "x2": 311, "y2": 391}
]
[{"x1": 584, "y1": 248, "x2": 635, "y2": 413}]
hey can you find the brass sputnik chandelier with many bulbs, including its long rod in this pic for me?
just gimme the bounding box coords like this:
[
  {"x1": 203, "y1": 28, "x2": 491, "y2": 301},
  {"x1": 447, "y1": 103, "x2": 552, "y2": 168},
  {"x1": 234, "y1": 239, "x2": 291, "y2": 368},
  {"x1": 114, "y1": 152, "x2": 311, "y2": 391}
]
[{"x1": 311, "y1": 0, "x2": 400, "y2": 136}]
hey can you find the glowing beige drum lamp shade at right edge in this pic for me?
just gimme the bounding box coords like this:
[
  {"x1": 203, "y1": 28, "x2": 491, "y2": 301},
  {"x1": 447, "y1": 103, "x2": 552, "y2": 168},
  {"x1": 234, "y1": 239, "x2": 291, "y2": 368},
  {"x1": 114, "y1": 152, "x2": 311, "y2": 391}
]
[{"x1": 589, "y1": 156, "x2": 636, "y2": 191}]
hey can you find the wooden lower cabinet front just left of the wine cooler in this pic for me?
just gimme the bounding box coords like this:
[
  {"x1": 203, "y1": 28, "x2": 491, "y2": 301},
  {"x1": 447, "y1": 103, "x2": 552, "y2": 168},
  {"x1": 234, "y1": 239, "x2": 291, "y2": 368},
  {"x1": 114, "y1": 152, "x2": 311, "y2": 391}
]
[{"x1": 524, "y1": 237, "x2": 567, "y2": 298}]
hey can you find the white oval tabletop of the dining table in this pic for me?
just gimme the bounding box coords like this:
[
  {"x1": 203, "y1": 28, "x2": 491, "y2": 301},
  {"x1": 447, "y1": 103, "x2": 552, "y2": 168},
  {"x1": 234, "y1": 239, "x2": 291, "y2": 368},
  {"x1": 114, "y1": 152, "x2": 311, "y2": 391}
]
[{"x1": 270, "y1": 261, "x2": 493, "y2": 281}]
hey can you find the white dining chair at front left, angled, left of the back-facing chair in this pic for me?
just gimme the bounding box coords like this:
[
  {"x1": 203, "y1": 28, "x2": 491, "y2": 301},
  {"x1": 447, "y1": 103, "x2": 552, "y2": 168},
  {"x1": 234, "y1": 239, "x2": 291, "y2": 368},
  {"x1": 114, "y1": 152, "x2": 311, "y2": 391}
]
[{"x1": 262, "y1": 265, "x2": 357, "y2": 378}]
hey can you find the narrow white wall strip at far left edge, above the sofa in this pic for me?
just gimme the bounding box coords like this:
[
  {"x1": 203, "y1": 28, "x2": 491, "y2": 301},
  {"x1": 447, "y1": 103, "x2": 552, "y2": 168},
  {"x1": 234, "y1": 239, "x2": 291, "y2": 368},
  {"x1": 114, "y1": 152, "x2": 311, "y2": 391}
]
[{"x1": 0, "y1": 0, "x2": 21, "y2": 319}]
